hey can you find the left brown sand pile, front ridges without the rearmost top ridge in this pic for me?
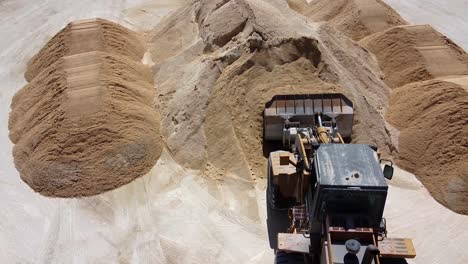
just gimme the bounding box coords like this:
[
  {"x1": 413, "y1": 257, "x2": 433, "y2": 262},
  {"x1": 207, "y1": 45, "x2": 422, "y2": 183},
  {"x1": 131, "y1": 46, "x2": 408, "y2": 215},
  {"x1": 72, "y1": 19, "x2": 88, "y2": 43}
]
[{"x1": 9, "y1": 19, "x2": 162, "y2": 197}]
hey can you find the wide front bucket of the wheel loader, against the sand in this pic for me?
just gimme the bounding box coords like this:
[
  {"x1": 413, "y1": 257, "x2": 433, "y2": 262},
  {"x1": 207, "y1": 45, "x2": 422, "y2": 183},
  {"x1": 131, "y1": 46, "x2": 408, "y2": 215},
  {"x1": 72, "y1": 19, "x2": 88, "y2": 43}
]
[{"x1": 263, "y1": 94, "x2": 354, "y2": 141}]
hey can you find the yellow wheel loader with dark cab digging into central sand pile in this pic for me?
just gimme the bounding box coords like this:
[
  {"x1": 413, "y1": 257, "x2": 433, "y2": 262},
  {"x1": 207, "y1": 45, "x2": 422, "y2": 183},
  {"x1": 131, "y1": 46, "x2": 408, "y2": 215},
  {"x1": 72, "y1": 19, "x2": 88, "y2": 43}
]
[{"x1": 263, "y1": 94, "x2": 416, "y2": 264}]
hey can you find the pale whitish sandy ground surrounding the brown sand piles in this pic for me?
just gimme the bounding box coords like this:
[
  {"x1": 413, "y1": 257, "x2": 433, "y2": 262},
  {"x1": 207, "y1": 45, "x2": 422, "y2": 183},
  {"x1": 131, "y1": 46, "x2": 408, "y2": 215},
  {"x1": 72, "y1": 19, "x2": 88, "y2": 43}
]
[{"x1": 0, "y1": 0, "x2": 468, "y2": 264}]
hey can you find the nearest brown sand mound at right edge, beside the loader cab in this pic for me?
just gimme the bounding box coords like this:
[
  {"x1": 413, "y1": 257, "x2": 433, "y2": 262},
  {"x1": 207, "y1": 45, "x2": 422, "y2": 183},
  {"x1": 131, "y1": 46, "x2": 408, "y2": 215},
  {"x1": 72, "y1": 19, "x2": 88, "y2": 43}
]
[{"x1": 387, "y1": 77, "x2": 468, "y2": 214}]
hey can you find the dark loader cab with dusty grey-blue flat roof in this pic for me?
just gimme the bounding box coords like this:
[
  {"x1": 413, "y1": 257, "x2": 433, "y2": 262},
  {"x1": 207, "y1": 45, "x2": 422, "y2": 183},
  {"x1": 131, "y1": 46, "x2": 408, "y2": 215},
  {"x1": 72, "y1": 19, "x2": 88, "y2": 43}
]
[{"x1": 306, "y1": 144, "x2": 388, "y2": 229}]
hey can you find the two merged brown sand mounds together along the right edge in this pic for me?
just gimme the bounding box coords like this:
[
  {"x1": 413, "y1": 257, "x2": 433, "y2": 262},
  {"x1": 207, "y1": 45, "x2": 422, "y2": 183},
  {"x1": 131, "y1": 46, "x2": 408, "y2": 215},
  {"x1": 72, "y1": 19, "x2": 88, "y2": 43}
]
[{"x1": 360, "y1": 25, "x2": 468, "y2": 214}]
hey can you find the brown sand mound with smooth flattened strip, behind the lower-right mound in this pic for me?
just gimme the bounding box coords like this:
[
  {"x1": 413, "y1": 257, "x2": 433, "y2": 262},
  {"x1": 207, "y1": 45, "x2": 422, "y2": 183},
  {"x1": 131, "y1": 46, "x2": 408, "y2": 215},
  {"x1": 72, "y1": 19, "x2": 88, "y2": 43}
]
[{"x1": 361, "y1": 25, "x2": 468, "y2": 87}]
